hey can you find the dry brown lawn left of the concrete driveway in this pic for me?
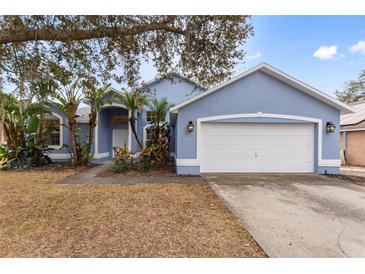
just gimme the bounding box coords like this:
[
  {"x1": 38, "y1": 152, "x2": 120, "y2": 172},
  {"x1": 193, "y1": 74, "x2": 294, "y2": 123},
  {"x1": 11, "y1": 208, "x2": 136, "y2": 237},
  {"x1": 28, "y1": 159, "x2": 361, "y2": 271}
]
[{"x1": 0, "y1": 167, "x2": 265, "y2": 257}]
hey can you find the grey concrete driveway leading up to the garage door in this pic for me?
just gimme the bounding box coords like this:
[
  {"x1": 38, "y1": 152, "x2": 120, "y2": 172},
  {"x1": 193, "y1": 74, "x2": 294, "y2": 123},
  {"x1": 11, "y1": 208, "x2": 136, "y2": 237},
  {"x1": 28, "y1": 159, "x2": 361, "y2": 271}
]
[{"x1": 204, "y1": 174, "x2": 365, "y2": 257}]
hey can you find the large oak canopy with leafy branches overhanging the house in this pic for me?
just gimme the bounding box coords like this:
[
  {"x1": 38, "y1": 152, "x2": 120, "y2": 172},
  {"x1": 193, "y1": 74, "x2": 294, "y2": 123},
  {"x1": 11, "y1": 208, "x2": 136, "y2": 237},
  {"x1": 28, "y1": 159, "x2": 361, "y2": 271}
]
[{"x1": 0, "y1": 16, "x2": 253, "y2": 93}]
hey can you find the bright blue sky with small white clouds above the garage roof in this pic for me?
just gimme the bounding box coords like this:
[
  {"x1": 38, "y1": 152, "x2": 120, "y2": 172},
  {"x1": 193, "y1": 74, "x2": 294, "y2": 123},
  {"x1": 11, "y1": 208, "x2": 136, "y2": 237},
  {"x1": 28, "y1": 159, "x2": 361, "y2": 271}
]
[{"x1": 137, "y1": 16, "x2": 365, "y2": 97}]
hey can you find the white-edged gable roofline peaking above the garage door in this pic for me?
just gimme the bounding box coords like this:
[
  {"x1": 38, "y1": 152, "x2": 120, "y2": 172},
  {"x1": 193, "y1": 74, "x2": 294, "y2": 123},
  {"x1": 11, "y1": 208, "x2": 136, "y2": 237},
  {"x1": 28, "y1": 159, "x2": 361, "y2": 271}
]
[{"x1": 170, "y1": 63, "x2": 354, "y2": 113}]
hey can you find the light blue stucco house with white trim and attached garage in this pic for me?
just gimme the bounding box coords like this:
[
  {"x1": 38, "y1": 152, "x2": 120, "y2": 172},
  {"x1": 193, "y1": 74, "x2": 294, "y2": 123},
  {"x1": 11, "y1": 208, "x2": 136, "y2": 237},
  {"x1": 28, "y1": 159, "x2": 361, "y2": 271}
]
[{"x1": 45, "y1": 64, "x2": 352, "y2": 174}]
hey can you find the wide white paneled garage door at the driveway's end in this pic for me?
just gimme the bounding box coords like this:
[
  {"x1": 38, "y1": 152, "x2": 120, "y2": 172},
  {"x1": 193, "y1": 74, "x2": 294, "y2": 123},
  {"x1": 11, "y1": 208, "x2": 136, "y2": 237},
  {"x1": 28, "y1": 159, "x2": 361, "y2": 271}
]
[{"x1": 200, "y1": 123, "x2": 314, "y2": 172}]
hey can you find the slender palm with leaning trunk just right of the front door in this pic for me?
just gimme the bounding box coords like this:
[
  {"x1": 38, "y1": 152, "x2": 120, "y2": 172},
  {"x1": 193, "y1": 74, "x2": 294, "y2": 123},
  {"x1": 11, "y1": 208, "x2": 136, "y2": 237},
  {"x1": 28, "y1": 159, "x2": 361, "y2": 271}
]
[{"x1": 116, "y1": 91, "x2": 148, "y2": 149}]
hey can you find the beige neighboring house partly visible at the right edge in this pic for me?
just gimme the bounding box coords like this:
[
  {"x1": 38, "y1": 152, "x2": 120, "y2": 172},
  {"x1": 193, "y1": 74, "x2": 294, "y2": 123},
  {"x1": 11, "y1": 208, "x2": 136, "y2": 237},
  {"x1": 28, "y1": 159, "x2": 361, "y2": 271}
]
[{"x1": 340, "y1": 100, "x2": 365, "y2": 166}]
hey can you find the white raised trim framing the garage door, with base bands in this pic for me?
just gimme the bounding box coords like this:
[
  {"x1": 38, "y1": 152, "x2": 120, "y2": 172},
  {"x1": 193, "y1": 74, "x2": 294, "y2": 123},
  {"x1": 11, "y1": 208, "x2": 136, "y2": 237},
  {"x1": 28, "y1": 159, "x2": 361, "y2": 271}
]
[{"x1": 176, "y1": 112, "x2": 341, "y2": 167}]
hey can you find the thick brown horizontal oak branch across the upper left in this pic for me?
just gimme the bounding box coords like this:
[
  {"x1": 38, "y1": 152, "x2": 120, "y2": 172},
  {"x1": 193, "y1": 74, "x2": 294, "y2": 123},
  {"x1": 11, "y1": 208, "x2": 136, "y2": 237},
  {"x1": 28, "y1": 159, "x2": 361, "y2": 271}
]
[{"x1": 0, "y1": 23, "x2": 185, "y2": 44}]
